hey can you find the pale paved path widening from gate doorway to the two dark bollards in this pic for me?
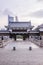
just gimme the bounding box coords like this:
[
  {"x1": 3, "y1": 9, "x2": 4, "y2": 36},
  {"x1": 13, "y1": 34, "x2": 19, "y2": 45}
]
[{"x1": 5, "y1": 40, "x2": 39, "y2": 50}]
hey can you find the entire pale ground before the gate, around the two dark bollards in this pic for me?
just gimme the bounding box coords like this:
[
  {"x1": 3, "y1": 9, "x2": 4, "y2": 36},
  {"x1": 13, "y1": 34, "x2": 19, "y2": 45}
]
[{"x1": 0, "y1": 40, "x2": 43, "y2": 65}]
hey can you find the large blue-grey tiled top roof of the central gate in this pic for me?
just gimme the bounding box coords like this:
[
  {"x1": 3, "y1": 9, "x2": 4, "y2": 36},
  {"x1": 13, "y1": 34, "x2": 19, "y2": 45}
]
[{"x1": 9, "y1": 22, "x2": 31, "y2": 27}]
